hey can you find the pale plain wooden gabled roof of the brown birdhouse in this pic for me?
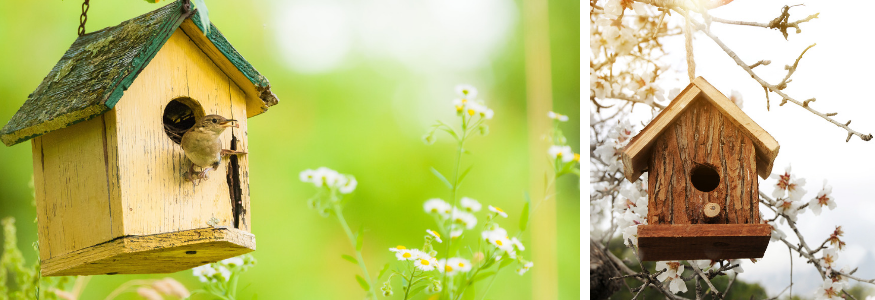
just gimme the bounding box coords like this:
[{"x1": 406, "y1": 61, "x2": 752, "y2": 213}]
[{"x1": 622, "y1": 77, "x2": 780, "y2": 182}]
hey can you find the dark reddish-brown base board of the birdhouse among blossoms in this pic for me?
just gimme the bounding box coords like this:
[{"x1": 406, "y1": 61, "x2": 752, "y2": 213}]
[{"x1": 638, "y1": 224, "x2": 771, "y2": 261}]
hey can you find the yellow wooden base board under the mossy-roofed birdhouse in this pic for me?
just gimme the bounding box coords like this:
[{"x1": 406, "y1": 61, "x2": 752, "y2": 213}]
[{"x1": 40, "y1": 227, "x2": 255, "y2": 276}]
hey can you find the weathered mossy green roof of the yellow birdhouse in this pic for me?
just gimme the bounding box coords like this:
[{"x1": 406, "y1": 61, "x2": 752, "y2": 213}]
[{"x1": 0, "y1": 1, "x2": 278, "y2": 146}]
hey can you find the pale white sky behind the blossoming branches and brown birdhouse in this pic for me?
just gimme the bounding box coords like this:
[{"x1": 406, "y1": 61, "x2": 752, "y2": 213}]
[{"x1": 581, "y1": 0, "x2": 875, "y2": 297}]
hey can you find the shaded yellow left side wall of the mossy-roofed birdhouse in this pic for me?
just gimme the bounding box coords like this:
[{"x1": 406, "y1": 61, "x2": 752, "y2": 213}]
[{"x1": 32, "y1": 116, "x2": 123, "y2": 259}]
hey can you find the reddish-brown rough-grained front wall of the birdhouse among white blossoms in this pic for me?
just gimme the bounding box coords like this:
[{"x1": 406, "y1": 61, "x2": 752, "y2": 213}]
[{"x1": 647, "y1": 99, "x2": 759, "y2": 224}]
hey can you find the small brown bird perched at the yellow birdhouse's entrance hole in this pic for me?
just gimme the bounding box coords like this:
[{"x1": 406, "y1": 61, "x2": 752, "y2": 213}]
[{"x1": 180, "y1": 115, "x2": 246, "y2": 181}]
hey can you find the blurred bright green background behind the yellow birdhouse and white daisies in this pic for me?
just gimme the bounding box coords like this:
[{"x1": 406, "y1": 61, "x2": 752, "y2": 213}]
[{"x1": 0, "y1": 0, "x2": 580, "y2": 299}]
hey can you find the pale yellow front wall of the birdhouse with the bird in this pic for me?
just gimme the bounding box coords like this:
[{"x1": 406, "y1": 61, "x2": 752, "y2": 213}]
[{"x1": 114, "y1": 30, "x2": 249, "y2": 235}]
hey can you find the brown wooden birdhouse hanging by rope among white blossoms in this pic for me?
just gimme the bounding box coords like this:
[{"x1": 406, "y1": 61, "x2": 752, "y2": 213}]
[{"x1": 622, "y1": 77, "x2": 779, "y2": 261}]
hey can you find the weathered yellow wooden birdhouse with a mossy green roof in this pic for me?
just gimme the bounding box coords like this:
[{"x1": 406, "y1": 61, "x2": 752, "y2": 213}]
[{"x1": 0, "y1": 1, "x2": 277, "y2": 276}]
